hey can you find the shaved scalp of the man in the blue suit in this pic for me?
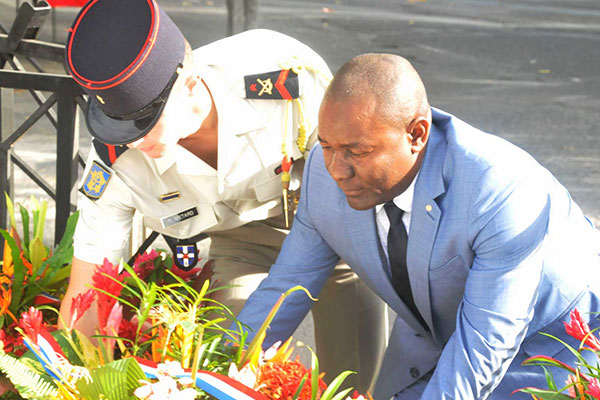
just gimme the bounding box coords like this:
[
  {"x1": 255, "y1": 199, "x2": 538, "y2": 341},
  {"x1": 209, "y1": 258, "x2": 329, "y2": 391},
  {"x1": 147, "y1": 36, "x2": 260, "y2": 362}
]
[{"x1": 323, "y1": 53, "x2": 430, "y2": 126}]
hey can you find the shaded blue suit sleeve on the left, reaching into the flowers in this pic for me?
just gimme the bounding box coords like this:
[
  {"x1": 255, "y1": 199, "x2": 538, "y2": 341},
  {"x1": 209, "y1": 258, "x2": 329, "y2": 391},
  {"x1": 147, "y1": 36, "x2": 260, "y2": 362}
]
[{"x1": 238, "y1": 149, "x2": 339, "y2": 347}]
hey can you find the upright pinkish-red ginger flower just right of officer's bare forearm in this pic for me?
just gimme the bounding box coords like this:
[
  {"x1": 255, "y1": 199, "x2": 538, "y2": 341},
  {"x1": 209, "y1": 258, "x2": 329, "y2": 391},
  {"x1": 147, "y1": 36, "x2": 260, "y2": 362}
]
[{"x1": 93, "y1": 258, "x2": 124, "y2": 331}]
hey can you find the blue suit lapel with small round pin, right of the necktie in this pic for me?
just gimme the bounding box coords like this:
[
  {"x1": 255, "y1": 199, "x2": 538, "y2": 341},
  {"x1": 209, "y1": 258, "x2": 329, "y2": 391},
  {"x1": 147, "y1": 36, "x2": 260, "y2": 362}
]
[{"x1": 407, "y1": 125, "x2": 446, "y2": 337}]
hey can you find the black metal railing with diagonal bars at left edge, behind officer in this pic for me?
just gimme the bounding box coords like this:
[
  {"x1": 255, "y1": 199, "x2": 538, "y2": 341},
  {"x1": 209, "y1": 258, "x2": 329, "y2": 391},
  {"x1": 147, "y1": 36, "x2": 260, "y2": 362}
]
[{"x1": 0, "y1": 1, "x2": 86, "y2": 250}]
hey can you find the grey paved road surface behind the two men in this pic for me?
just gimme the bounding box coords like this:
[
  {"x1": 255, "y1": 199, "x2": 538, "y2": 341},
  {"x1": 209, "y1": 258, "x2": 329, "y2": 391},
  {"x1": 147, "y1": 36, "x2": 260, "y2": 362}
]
[{"x1": 0, "y1": 0, "x2": 600, "y2": 370}]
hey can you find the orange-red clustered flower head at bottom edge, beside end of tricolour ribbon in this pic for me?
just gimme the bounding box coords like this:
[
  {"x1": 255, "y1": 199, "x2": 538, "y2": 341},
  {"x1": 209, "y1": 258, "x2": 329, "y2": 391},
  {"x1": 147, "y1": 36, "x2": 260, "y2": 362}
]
[{"x1": 257, "y1": 360, "x2": 327, "y2": 400}]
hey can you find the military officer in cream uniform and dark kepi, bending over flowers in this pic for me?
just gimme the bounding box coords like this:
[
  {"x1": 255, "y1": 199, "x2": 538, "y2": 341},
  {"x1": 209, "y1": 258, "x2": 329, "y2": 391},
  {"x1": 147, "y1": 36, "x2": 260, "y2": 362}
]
[{"x1": 61, "y1": 0, "x2": 386, "y2": 391}]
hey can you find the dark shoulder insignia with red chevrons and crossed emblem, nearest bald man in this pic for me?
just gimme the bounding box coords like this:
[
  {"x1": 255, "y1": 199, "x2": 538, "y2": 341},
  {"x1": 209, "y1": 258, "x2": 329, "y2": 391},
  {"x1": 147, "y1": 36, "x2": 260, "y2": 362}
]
[{"x1": 244, "y1": 69, "x2": 300, "y2": 100}]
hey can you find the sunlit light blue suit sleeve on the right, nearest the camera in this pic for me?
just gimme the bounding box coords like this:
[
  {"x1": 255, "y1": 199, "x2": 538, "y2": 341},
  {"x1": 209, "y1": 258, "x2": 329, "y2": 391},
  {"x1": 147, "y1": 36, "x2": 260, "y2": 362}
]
[{"x1": 421, "y1": 168, "x2": 550, "y2": 399}]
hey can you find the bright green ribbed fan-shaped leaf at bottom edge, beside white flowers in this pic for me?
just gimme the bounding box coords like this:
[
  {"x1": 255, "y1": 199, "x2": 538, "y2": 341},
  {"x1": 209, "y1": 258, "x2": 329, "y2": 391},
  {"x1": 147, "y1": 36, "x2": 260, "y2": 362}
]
[{"x1": 76, "y1": 358, "x2": 146, "y2": 400}]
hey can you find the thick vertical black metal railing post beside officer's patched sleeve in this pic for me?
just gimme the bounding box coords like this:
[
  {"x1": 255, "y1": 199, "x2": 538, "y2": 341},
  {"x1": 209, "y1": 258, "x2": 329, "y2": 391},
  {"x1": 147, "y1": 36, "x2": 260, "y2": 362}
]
[{"x1": 54, "y1": 92, "x2": 79, "y2": 244}]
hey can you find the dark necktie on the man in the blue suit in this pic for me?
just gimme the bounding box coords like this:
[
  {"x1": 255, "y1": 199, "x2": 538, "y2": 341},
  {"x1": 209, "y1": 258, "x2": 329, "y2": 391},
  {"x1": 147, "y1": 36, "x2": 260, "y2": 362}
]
[{"x1": 383, "y1": 201, "x2": 429, "y2": 330}]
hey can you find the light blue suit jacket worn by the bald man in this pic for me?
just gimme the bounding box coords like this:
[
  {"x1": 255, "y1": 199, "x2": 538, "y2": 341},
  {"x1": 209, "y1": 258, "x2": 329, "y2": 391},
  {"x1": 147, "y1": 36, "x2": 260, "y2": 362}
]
[{"x1": 239, "y1": 109, "x2": 600, "y2": 400}]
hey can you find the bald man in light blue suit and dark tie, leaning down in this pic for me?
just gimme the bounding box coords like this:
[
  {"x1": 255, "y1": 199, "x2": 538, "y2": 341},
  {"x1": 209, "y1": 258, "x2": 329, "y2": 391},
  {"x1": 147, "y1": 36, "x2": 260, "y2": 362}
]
[{"x1": 239, "y1": 54, "x2": 600, "y2": 400}]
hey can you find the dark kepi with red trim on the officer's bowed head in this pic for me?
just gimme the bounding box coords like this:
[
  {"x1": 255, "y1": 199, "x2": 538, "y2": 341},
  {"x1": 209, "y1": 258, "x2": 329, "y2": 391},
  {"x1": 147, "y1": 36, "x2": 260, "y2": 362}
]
[{"x1": 65, "y1": 0, "x2": 185, "y2": 145}]
